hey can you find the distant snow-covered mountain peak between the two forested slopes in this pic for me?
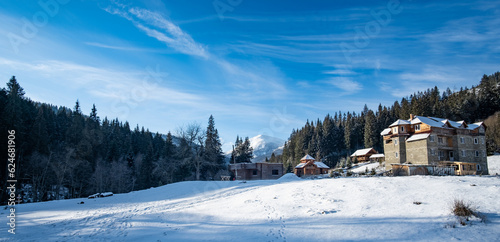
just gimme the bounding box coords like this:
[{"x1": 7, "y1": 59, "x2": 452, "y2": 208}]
[{"x1": 250, "y1": 135, "x2": 285, "y2": 162}]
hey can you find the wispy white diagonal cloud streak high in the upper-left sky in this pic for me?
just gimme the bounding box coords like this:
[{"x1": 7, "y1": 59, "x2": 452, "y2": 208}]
[{"x1": 104, "y1": 5, "x2": 209, "y2": 58}]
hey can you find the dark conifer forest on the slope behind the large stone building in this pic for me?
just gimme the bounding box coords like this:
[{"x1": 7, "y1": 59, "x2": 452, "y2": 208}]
[{"x1": 276, "y1": 72, "x2": 500, "y2": 171}]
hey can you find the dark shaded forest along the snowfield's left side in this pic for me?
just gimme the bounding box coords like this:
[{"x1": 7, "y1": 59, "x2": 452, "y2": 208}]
[{"x1": 0, "y1": 77, "x2": 227, "y2": 203}]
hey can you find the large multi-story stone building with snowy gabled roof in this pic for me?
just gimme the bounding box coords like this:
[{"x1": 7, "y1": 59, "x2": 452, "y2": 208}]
[{"x1": 381, "y1": 115, "x2": 488, "y2": 175}]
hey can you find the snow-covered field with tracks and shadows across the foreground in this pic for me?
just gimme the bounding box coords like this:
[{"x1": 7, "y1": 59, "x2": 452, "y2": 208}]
[{"x1": 0, "y1": 174, "x2": 500, "y2": 241}]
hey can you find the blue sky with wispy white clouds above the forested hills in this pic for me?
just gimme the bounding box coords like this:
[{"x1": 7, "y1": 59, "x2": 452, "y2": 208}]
[{"x1": 0, "y1": 0, "x2": 500, "y2": 149}]
